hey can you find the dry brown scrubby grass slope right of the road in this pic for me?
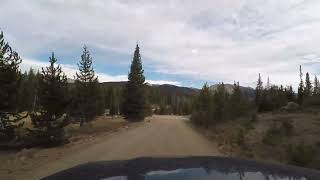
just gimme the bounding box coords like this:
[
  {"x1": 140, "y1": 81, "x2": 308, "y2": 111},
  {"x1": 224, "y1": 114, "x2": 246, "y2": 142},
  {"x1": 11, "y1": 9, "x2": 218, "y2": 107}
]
[{"x1": 204, "y1": 111, "x2": 320, "y2": 169}]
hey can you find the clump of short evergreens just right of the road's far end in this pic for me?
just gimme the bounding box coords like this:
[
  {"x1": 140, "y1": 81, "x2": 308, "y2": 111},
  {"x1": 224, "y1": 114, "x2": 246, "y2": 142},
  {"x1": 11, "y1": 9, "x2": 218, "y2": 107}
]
[{"x1": 191, "y1": 83, "x2": 252, "y2": 128}]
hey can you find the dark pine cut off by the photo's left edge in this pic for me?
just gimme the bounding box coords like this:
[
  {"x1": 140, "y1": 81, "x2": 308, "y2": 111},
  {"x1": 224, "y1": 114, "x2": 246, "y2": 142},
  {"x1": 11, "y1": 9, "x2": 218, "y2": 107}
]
[{"x1": 0, "y1": 32, "x2": 27, "y2": 141}]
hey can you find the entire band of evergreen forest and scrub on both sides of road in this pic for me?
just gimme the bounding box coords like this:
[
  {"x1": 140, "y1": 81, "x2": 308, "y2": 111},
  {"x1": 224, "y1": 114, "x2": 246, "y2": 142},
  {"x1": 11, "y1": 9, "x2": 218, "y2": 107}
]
[{"x1": 0, "y1": 27, "x2": 320, "y2": 173}]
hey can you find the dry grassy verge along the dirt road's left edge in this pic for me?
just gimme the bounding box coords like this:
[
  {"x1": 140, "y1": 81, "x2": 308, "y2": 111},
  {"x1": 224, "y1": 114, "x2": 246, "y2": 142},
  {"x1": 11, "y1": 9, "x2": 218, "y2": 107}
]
[{"x1": 0, "y1": 116, "x2": 131, "y2": 179}]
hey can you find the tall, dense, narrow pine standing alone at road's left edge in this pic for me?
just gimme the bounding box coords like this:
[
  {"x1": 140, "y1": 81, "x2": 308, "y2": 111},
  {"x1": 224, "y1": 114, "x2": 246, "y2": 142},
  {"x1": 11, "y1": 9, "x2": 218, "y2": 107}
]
[{"x1": 123, "y1": 44, "x2": 147, "y2": 121}]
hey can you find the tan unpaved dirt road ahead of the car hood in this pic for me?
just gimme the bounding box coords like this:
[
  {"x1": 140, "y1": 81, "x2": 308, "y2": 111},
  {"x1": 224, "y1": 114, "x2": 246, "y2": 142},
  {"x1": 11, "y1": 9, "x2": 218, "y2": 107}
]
[{"x1": 11, "y1": 116, "x2": 219, "y2": 179}]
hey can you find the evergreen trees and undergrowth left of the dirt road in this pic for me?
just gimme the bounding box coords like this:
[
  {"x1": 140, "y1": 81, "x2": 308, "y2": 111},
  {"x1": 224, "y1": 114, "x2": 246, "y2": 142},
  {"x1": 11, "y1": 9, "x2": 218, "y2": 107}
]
[{"x1": 0, "y1": 32, "x2": 195, "y2": 149}]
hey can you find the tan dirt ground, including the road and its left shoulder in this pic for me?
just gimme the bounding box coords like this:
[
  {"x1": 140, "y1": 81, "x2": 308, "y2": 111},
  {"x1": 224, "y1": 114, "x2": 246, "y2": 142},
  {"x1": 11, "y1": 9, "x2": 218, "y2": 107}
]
[{"x1": 0, "y1": 116, "x2": 220, "y2": 179}]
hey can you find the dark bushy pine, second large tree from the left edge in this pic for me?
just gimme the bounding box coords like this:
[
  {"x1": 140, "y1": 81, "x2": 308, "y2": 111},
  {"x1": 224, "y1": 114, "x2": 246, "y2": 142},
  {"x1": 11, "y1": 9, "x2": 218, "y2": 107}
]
[{"x1": 30, "y1": 53, "x2": 69, "y2": 145}]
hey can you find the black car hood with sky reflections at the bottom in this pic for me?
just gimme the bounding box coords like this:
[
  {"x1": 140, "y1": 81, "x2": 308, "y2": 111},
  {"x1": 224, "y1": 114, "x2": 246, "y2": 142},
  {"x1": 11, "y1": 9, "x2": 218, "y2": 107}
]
[{"x1": 43, "y1": 157, "x2": 320, "y2": 180}]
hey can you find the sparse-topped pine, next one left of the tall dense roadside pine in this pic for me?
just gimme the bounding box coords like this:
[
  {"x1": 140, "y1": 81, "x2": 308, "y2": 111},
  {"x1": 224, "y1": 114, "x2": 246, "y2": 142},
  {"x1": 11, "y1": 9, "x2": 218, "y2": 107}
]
[{"x1": 73, "y1": 46, "x2": 104, "y2": 126}]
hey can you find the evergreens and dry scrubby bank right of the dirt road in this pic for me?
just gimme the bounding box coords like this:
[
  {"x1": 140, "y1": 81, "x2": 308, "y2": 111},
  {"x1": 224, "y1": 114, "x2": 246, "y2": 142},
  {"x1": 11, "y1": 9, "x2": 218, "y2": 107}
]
[{"x1": 191, "y1": 67, "x2": 320, "y2": 169}]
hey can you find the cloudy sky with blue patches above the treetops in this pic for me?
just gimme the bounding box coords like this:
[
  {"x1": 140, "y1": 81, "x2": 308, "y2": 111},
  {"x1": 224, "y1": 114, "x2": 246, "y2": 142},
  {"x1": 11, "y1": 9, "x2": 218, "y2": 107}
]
[{"x1": 0, "y1": 0, "x2": 320, "y2": 87}]
